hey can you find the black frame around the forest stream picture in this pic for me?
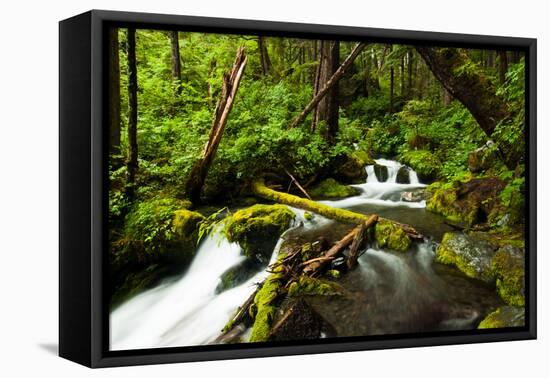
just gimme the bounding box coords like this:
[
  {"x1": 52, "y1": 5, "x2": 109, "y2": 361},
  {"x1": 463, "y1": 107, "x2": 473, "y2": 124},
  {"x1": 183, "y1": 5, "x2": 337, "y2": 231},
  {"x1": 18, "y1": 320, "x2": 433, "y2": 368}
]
[{"x1": 59, "y1": 10, "x2": 537, "y2": 368}]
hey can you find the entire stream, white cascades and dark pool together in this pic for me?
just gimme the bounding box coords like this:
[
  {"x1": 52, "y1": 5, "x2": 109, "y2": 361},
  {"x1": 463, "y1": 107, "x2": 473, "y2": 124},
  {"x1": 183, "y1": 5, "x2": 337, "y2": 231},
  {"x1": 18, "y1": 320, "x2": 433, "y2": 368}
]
[{"x1": 110, "y1": 159, "x2": 506, "y2": 350}]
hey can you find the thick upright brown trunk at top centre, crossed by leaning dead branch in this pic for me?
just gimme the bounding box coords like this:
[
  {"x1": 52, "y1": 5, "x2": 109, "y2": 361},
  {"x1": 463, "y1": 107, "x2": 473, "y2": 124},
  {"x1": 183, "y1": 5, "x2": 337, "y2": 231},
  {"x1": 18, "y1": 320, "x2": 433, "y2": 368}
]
[{"x1": 312, "y1": 41, "x2": 340, "y2": 140}]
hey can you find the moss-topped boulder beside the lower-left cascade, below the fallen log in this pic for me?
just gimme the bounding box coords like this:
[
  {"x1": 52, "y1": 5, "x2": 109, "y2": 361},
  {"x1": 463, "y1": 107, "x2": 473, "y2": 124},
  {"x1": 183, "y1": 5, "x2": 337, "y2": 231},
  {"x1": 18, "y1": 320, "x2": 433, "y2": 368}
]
[{"x1": 224, "y1": 205, "x2": 295, "y2": 263}]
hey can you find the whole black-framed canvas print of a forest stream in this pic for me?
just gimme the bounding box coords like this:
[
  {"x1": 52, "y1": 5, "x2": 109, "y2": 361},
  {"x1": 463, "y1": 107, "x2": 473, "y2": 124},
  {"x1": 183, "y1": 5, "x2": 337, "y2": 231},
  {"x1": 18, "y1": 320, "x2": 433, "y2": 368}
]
[{"x1": 59, "y1": 10, "x2": 536, "y2": 367}]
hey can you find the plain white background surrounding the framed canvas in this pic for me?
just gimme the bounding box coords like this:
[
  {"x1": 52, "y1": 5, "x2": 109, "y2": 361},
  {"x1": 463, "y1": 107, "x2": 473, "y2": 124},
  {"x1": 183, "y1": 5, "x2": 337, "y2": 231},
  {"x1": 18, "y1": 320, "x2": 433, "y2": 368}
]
[{"x1": 0, "y1": 0, "x2": 550, "y2": 378}]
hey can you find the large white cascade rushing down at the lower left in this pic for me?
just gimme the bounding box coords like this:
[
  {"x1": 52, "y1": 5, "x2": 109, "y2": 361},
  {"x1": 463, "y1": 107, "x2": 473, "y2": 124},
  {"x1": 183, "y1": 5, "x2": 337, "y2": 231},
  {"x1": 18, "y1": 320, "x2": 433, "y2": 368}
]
[{"x1": 110, "y1": 209, "x2": 314, "y2": 350}]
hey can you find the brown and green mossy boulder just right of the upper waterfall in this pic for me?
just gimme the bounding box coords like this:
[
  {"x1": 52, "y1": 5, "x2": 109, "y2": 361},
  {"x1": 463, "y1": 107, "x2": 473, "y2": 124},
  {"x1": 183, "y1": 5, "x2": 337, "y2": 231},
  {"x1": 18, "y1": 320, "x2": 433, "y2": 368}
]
[{"x1": 426, "y1": 177, "x2": 506, "y2": 227}]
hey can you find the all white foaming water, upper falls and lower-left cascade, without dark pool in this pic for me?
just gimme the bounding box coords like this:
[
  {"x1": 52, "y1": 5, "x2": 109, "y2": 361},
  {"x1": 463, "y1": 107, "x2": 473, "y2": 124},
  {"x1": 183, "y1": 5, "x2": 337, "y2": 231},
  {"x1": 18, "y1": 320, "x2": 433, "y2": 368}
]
[{"x1": 110, "y1": 159, "x2": 432, "y2": 350}]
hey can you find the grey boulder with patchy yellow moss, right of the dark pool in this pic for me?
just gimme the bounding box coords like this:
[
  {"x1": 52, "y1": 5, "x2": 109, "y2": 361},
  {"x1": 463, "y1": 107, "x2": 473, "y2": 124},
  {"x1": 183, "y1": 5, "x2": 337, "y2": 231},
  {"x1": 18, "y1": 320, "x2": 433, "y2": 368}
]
[{"x1": 435, "y1": 232, "x2": 496, "y2": 283}]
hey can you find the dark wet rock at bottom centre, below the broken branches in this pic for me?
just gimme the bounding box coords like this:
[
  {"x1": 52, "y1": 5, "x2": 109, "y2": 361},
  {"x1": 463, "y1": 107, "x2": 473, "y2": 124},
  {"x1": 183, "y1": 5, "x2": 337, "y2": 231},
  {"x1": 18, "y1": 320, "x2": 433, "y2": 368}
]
[{"x1": 270, "y1": 299, "x2": 323, "y2": 341}]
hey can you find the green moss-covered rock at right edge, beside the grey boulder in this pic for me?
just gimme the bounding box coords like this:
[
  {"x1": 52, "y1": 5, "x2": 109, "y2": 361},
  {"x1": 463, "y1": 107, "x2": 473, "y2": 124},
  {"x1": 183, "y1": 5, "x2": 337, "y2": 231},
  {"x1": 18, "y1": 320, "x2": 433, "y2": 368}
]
[{"x1": 492, "y1": 247, "x2": 525, "y2": 306}]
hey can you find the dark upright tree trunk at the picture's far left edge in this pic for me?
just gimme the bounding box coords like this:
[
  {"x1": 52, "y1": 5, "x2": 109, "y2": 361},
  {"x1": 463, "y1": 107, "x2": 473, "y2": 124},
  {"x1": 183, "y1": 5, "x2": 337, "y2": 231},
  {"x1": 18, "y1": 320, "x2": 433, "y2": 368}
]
[{"x1": 109, "y1": 27, "x2": 120, "y2": 156}]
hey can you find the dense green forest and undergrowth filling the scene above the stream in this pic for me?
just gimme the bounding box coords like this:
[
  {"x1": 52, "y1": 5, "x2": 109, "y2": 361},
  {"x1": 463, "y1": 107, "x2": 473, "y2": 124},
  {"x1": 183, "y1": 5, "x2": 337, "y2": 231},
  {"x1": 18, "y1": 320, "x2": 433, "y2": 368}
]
[{"x1": 109, "y1": 29, "x2": 525, "y2": 328}]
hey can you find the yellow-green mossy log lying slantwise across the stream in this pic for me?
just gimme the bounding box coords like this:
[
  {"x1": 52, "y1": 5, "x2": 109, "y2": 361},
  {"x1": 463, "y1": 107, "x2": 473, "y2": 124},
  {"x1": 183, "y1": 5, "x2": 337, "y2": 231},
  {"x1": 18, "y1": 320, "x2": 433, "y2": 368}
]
[{"x1": 252, "y1": 180, "x2": 424, "y2": 240}]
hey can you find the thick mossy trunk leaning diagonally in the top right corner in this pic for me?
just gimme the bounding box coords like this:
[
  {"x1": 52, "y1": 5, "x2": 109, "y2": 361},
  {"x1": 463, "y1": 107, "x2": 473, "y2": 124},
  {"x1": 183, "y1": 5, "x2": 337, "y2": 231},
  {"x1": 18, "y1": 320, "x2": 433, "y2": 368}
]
[{"x1": 416, "y1": 46, "x2": 517, "y2": 169}]
